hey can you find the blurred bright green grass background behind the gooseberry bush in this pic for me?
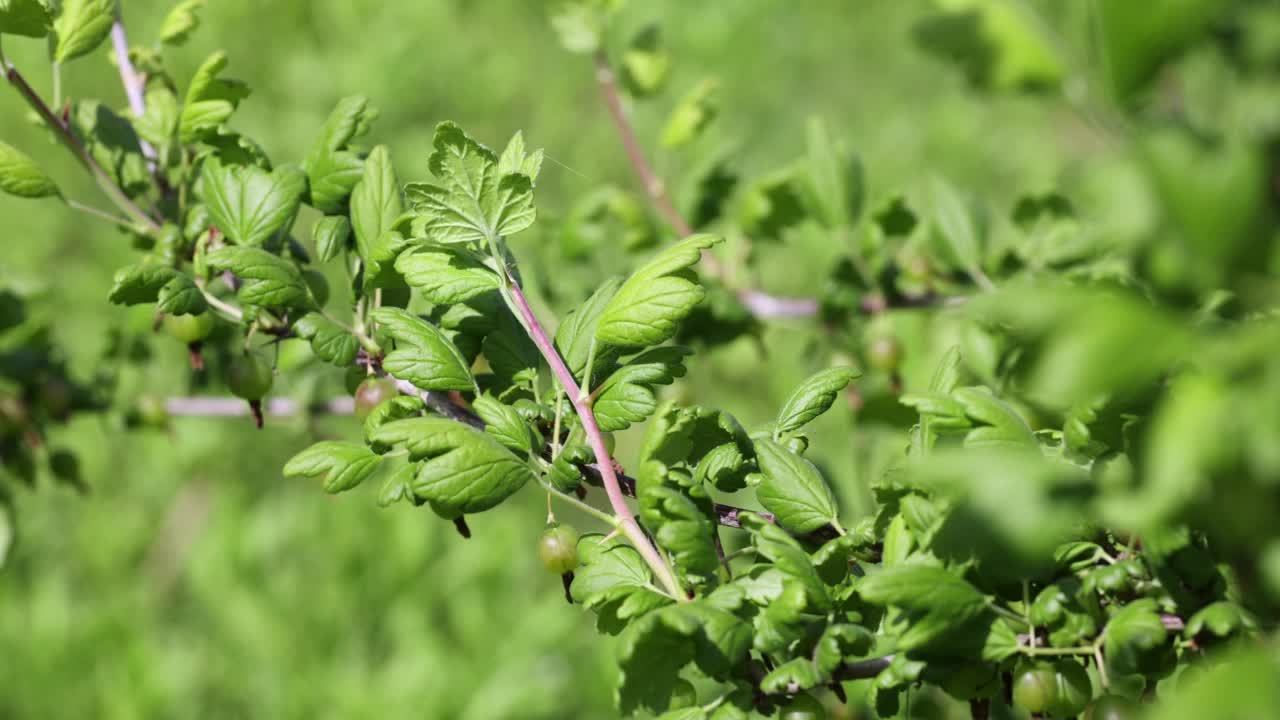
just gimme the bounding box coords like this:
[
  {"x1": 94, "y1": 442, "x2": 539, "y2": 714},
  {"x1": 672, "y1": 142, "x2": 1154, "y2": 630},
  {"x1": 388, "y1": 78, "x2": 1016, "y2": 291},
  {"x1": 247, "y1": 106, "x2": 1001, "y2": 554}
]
[{"x1": 0, "y1": 0, "x2": 1106, "y2": 719}]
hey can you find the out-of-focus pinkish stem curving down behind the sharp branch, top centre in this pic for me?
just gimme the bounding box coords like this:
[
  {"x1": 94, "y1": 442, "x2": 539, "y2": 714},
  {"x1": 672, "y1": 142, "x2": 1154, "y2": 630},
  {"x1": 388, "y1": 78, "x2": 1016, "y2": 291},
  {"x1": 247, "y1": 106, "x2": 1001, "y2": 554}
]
[{"x1": 595, "y1": 50, "x2": 818, "y2": 318}]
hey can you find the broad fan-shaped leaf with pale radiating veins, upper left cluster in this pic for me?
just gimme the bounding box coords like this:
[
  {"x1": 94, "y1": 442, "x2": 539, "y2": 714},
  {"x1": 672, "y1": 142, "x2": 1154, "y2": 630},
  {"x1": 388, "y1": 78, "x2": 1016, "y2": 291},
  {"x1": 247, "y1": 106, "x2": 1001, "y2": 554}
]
[{"x1": 202, "y1": 160, "x2": 307, "y2": 246}]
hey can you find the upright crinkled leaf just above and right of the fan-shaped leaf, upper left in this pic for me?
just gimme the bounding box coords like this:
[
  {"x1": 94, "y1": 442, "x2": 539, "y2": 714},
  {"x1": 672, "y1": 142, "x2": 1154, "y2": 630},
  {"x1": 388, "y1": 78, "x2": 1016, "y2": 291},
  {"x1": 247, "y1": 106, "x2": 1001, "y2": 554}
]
[{"x1": 305, "y1": 95, "x2": 378, "y2": 214}]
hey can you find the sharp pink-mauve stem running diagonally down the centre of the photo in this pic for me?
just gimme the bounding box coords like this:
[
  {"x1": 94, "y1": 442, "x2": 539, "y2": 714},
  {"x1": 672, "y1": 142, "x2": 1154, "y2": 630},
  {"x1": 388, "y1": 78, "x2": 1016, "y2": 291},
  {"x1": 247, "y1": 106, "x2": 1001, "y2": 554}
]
[{"x1": 507, "y1": 282, "x2": 689, "y2": 602}]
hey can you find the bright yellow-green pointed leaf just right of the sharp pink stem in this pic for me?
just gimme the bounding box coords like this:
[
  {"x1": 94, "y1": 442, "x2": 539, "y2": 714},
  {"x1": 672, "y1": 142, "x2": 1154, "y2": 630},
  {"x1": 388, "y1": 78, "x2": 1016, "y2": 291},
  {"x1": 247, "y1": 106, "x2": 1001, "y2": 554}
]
[{"x1": 595, "y1": 234, "x2": 722, "y2": 347}]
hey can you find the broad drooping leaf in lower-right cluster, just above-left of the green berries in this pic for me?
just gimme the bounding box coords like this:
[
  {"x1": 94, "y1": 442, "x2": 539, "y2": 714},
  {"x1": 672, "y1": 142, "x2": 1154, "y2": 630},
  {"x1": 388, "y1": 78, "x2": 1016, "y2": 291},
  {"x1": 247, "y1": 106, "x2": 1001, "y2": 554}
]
[{"x1": 858, "y1": 564, "x2": 987, "y2": 651}]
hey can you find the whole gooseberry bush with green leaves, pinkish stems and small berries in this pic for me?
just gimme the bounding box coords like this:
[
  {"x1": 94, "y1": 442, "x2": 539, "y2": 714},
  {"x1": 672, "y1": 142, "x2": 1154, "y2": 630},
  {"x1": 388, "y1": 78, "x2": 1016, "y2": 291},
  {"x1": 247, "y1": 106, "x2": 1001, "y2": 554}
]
[{"x1": 0, "y1": 0, "x2": 1280, "y2": 720}]
